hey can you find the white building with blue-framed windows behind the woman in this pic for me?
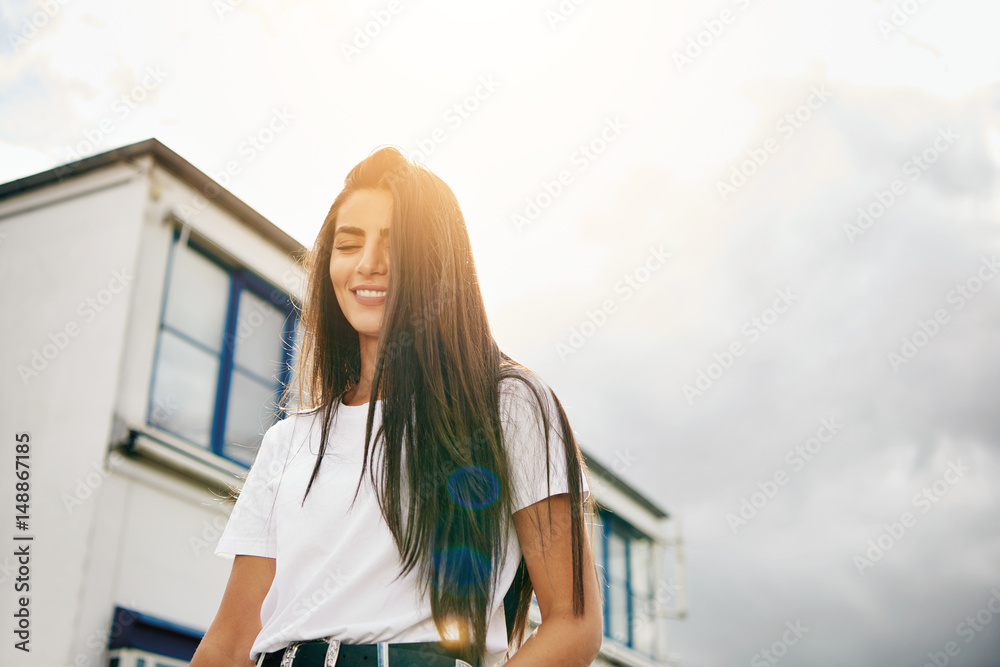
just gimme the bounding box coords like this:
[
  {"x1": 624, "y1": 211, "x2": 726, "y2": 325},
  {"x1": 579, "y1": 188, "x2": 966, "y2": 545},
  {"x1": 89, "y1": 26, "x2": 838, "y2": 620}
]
[{"x1": 0, "y1": 139, "x2": 684, "y2": 667}]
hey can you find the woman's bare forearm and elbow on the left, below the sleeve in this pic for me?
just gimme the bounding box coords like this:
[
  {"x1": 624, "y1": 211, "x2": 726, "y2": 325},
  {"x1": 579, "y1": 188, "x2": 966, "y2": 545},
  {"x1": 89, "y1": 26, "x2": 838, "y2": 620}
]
[{"x1": 191, "y1": 555, "x2": 275, "y2": 667}]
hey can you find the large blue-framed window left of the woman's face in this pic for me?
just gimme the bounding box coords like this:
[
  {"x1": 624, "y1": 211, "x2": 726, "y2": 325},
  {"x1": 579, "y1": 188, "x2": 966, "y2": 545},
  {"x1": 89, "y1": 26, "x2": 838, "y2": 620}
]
[{"x1": 147, "y1": 229, "x2": 301, "y2": 466}]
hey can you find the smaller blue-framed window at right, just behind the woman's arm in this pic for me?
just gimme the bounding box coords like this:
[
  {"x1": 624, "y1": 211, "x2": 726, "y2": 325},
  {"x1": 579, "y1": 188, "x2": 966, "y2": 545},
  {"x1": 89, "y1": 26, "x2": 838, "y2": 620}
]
[{"x1": 594, "y1": 509, "x2": 657, "y2": 658}]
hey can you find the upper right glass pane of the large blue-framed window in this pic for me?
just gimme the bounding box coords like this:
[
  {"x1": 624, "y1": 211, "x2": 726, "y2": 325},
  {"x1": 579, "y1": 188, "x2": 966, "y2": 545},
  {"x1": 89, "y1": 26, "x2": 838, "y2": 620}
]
[{"x1": 233, "y1": 290, "x2": 285, "y2": 385}]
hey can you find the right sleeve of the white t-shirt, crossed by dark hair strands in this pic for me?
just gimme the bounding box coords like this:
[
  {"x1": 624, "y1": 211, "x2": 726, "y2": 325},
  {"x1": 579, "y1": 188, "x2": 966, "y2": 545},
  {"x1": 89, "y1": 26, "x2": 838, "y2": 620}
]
[{"x1": 500, "y1": 379, "x2": 590, "y2": 512}]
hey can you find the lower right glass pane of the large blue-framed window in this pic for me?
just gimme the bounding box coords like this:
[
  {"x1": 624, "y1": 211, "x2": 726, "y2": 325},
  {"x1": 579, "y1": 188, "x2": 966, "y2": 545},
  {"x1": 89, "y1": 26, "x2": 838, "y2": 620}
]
[{"x1": 222, "y1": 370, "x2": 278, "y2": 466}]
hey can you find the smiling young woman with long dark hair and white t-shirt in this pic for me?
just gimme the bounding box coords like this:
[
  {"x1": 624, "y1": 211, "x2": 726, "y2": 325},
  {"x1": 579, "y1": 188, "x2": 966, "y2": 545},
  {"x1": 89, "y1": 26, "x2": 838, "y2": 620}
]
[{"x1": 191, "y1": 147, "x2": 603, "y2": 667}]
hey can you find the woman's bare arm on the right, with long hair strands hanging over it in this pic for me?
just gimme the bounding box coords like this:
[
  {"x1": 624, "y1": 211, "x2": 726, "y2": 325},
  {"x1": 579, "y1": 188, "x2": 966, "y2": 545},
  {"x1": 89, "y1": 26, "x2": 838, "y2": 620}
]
[{"x1": 506, "y1": 493, "x2": 604, "y2": 667}]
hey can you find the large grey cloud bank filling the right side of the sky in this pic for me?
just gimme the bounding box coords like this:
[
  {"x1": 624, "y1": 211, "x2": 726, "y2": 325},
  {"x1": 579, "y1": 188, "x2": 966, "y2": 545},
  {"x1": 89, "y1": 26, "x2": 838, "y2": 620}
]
[{"x1": 552, "y1": 69, "x2": 1000, "y2": 665}]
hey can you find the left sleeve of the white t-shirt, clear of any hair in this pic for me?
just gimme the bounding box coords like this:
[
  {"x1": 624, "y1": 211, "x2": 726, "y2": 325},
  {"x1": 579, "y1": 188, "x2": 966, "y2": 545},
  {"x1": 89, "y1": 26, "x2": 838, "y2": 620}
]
[{"x1": 215, "y1": 422, "x2": 284, "y2": 558}]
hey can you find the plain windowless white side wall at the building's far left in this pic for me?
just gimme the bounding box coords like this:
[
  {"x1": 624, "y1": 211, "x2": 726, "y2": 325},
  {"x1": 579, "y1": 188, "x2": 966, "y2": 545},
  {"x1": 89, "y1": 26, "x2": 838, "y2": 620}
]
[{"x1": 0, "y1": 166, "x2": 147, "y2": 667}]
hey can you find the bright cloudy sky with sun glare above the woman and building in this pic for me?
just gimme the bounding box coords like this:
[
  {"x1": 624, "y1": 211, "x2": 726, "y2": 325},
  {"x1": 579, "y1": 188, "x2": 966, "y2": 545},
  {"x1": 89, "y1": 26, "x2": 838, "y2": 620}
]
[{"x1": 0, "y1": 0, "x2": 1000, "y2": 667}]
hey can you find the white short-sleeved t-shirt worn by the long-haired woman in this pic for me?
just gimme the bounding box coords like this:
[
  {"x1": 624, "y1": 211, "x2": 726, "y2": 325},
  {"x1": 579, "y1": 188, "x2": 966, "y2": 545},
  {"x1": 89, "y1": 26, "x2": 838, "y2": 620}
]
[{"x1": 215, "y1": 380, "x2": 590, "y2": 667}]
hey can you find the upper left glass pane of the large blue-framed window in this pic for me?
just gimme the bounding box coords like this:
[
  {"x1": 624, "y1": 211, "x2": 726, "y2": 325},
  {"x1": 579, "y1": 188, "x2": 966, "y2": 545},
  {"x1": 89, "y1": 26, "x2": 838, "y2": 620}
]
[{"x1": 163, "y1": 245, "x2": 229, "y2": 352}]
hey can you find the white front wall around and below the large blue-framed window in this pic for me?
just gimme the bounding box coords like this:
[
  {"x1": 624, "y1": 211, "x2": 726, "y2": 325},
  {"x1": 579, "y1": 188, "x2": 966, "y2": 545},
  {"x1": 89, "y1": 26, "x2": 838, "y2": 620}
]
[{"x1": 69, "y1": 160, "x2": 301, "y2": 667}]
